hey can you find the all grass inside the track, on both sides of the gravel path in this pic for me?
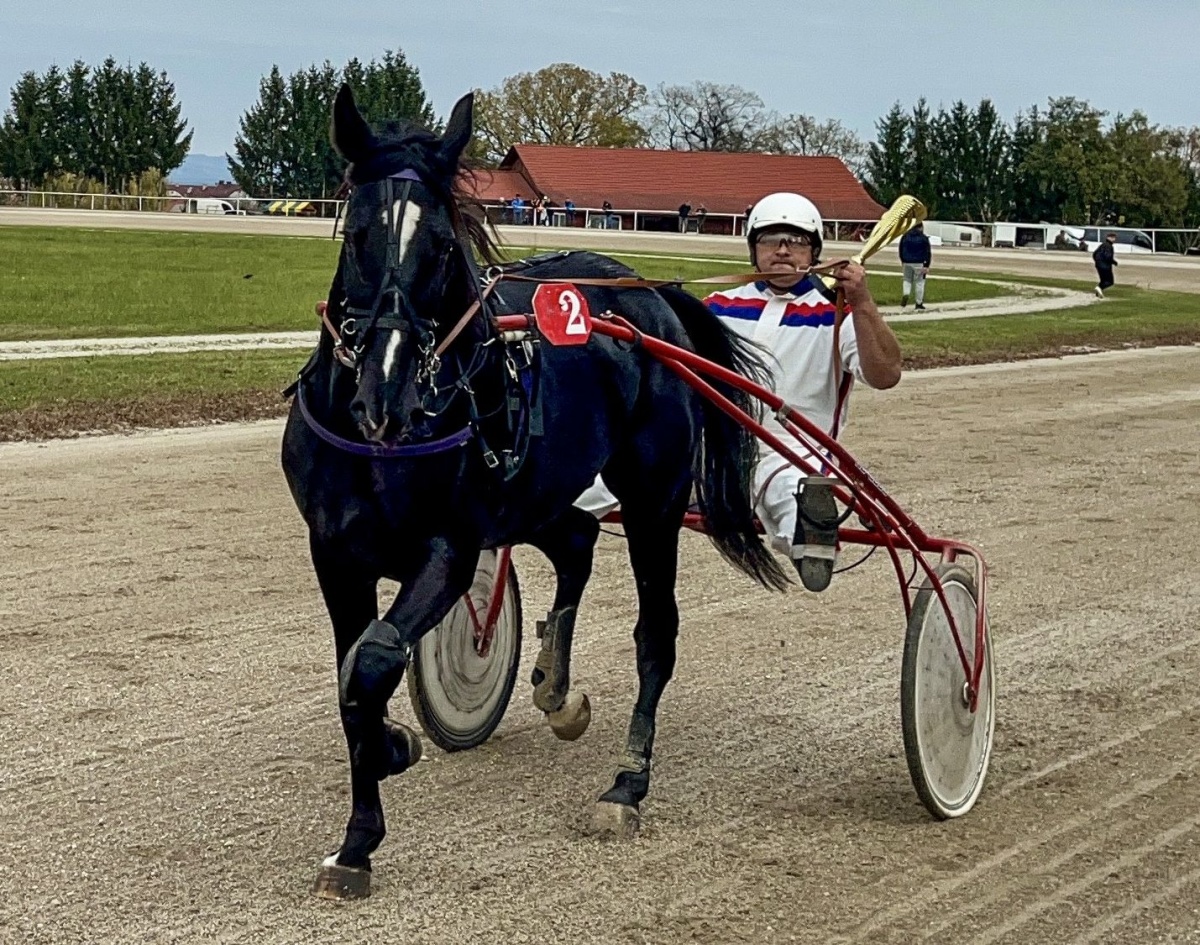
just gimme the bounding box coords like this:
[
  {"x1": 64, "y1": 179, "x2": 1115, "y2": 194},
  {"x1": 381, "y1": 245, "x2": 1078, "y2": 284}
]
[{"x1": 0, "y1": 227, "x2": 1200, "y2": 440}]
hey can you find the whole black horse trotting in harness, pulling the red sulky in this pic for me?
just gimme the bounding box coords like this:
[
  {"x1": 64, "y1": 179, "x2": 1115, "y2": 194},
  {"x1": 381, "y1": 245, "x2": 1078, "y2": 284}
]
[{"x1": 282, "y1": 86, "x2": 787, "y2": 896}]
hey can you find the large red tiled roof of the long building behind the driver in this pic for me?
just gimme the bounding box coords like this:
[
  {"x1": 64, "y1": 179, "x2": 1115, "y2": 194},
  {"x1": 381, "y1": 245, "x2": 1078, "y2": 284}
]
[{"x1": 500, "y1": 144, "x2": 884, "y2": 219}]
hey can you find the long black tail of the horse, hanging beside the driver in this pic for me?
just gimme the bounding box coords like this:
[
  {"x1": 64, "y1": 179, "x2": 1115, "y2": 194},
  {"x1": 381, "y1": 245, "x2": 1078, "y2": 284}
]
[{"x1": 659, "y1": 287, "x2": 791, "y2": 590}]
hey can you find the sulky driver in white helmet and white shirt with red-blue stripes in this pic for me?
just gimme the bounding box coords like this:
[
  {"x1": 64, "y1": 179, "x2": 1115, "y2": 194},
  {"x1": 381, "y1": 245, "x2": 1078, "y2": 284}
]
[{"x1": 576, "y1": 193, "x2": 900, "y2": 591}]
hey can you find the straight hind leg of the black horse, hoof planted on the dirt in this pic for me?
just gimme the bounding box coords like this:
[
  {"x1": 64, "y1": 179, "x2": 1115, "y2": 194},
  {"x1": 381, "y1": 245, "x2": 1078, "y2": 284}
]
[{"x1": 593, "y1": 513, "x2": 682, "y2": 837}]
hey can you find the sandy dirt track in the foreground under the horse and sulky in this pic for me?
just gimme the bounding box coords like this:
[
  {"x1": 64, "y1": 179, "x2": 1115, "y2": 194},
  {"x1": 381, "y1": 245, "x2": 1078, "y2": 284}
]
[{"x1": 0, "y1": 348, "x2": 1200, "y2": 945}]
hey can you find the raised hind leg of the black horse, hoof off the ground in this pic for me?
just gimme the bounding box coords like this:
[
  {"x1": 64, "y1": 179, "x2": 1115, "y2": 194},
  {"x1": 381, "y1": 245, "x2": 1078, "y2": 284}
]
[{"x1": 530, "y1": 507, "x2": 600, "y2": 741}]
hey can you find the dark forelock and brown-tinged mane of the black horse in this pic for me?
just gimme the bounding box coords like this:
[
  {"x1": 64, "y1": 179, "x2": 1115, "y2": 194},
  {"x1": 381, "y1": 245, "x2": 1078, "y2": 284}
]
[{"x1": 346, "y1": 120, "x2": 502, "y2": 266}]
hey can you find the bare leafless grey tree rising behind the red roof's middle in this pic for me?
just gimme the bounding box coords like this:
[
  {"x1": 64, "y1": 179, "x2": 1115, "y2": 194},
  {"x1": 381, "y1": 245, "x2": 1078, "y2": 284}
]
[{"x1": 649, "y1": 82, "x2": 770, "y2": 151}]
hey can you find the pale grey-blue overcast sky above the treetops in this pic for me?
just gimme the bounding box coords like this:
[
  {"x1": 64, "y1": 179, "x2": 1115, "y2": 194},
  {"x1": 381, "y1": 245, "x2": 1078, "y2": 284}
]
[{"x1": 0, "y1": 0, "x2": 1200, "y2": 155}]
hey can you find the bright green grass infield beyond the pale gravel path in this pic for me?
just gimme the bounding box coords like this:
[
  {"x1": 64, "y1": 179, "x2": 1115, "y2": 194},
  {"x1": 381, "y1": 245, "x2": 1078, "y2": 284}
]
[{"x1": 0, "y1": 227, "x2": 1006, "y2": 341}]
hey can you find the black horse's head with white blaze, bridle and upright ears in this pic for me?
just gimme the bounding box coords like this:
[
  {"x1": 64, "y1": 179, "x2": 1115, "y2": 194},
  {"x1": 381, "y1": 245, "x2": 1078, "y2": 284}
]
[{"x1": 330, "y1": 85, "x2": 486, "y2": 443}]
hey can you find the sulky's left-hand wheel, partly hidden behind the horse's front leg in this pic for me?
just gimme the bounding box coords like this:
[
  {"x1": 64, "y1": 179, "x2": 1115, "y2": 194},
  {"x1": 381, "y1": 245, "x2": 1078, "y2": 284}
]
[{"x1": 408, "y1": 550, "x2": 521, "y2": 752}]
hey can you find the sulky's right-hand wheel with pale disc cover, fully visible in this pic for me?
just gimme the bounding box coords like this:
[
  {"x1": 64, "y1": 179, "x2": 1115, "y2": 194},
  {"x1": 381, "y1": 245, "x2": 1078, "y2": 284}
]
[{"x1": 900, "y1": 564, "x2": 996, "y2": 820}]
